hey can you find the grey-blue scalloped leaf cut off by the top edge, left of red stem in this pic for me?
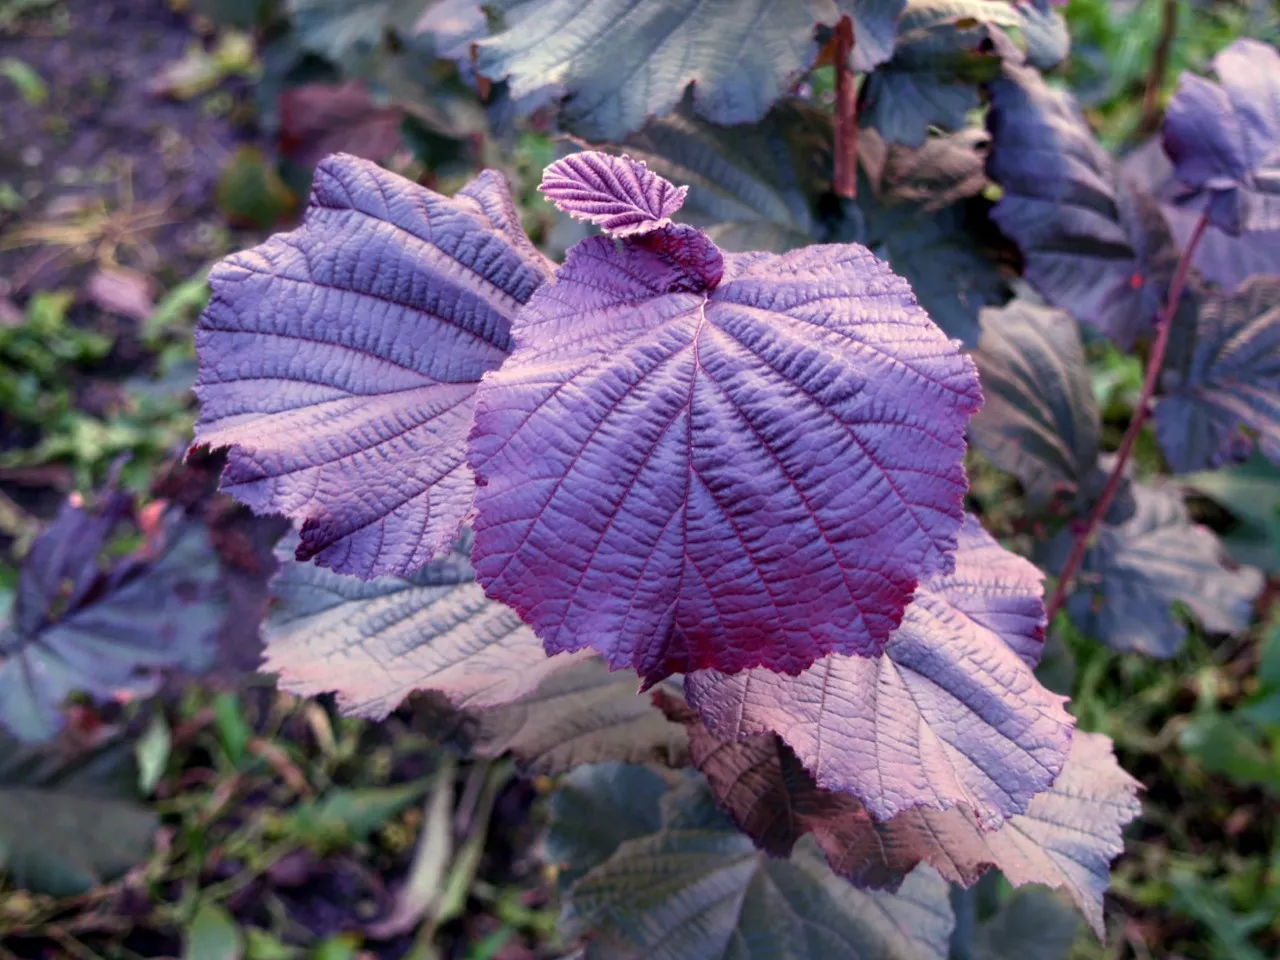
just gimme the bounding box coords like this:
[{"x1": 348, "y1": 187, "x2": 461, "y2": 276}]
[{"x1": 477, "y1": 0, "x2": 836, "y2": 143}]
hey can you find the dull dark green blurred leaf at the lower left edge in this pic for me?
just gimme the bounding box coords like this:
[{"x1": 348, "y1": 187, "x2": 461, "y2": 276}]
[{"x1": 0, "y1": 731, "x2": 160, "y2": 897}]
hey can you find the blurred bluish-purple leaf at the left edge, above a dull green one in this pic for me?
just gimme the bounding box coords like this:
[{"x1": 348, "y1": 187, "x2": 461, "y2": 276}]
[{"x1": 0, "y1": 493, "x2": 227, "y2": 741}]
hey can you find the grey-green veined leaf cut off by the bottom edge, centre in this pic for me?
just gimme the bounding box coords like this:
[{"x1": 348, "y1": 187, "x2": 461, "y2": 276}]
[{"x1": 552, "y1": 774, "x2": 954, "y2": 960}]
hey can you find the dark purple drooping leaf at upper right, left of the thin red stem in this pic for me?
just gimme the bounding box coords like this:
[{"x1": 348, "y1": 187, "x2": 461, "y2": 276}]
[{"x1": 987, "y1": 64, "x2": 1178, "y2": 349}]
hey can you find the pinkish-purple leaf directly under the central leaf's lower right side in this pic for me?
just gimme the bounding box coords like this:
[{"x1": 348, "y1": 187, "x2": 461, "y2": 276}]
[{"x1": 685, "y1": 517, "x2": 1074, "y2": 828}]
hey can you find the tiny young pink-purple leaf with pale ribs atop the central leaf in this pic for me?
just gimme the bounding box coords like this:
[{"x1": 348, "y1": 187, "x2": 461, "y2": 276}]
[{"x1": 539, "y1": 150, "x2": 689, "y2": 237}]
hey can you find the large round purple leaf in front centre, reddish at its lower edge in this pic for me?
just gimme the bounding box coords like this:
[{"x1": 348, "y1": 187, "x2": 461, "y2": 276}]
[{"x1": 471, "y1": 237, "x2": 982, "y2": 682}]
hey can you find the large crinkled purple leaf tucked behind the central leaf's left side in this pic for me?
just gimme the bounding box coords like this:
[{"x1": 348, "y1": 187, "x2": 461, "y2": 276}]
[{"x1": 196, "y1": 155, "x2": 550, "y2": 577}]
